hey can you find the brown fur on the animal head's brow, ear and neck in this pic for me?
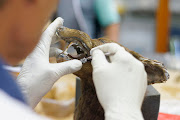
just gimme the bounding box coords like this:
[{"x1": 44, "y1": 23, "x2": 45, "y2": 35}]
[{"x1": 58, "y1": 27, "x2": 169, "y2": 120}]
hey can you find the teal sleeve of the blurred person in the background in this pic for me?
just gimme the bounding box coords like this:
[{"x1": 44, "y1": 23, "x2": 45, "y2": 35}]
[{"x1": 94, "y1": 0, "x2": 120, "y2": 27}]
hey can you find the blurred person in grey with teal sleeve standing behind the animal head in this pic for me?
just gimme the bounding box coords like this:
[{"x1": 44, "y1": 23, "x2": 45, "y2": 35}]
[{"x1": 56, "y1": 0, "x2": 120, "y2": 42}]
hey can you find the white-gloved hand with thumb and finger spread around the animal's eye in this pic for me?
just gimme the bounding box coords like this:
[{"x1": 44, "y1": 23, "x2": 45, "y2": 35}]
[{"x1": 17, "y1": 18, "x2": 82, "y2": 108}]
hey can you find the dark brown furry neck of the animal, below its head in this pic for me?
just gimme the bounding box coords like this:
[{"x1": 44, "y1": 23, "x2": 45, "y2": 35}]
[{"x1": 74, "y1": 66, "x2": 104, "y2": 120}]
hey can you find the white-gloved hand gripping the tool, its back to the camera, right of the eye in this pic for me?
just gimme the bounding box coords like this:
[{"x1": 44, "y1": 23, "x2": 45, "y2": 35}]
[{"x1": 91, "y1": 43, "x2": 147, "y2": 120}]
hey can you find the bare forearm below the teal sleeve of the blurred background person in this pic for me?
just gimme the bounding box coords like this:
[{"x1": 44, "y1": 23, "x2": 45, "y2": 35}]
[{"x1": 105, "y1": 24, "x2": 120, "y2": 42}]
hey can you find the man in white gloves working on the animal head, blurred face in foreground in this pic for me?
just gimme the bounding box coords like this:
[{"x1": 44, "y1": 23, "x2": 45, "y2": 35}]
[{"x1": 0, "y1": 0, "x2": 147, "y2": 120}]
